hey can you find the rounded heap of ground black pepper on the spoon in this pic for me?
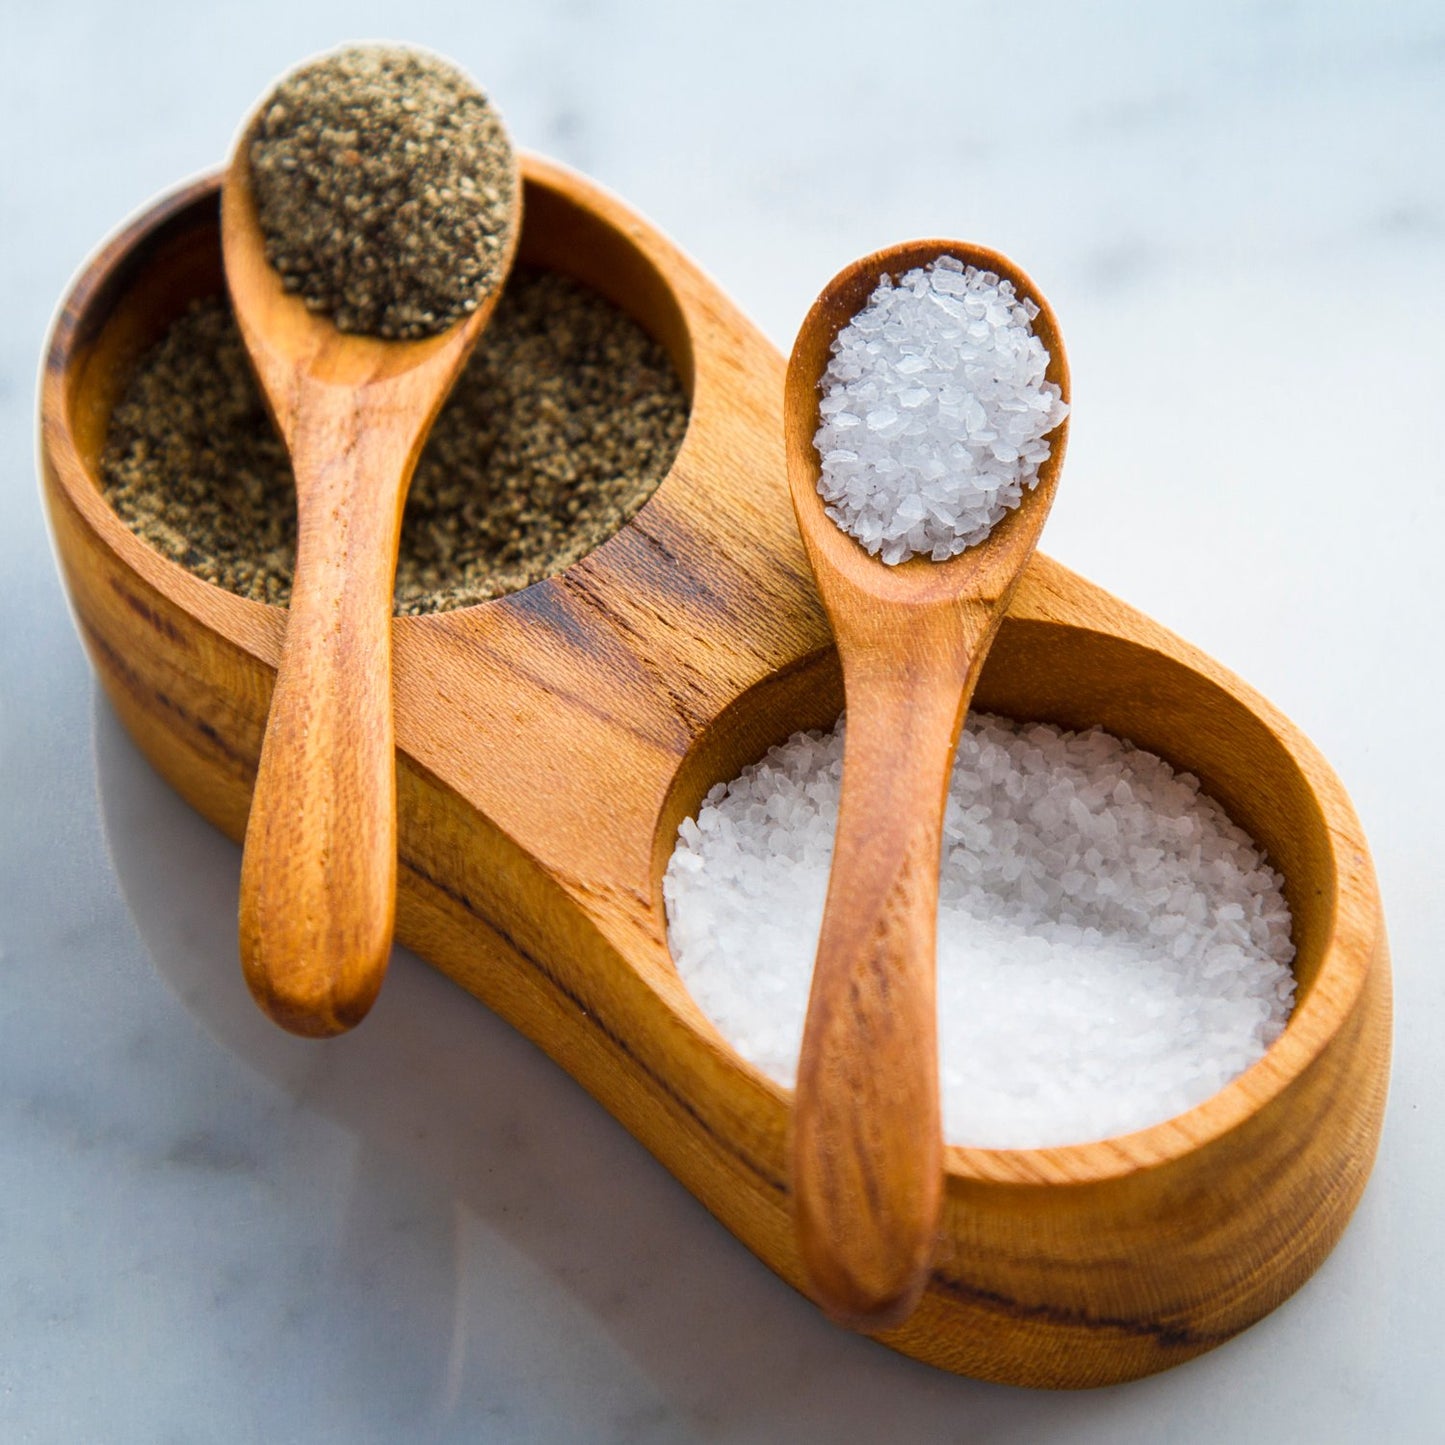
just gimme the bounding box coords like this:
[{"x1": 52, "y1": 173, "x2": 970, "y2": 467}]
[{"x1": 250, "y1": 45, "x2": 516, "y2": 338}]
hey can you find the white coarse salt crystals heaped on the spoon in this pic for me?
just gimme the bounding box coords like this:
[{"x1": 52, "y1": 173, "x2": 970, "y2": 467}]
[{"x1": 814, "y1": 256, "x2": 1068, "y2": 565}]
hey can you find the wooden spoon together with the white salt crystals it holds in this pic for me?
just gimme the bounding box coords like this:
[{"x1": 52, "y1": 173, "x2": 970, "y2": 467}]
[{"x1": 785, "y1": 240, "x2": 1069, "y2": 1329}]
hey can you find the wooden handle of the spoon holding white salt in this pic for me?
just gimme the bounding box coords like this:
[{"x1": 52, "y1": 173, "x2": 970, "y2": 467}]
[{"x1": 793, "y1": 639, "x2": 977, "y2": 1329}]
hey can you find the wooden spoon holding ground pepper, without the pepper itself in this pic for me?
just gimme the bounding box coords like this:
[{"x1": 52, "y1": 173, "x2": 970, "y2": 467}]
[{"x1": 221, "y1": 118, "x2": 522, "y2": 1038}]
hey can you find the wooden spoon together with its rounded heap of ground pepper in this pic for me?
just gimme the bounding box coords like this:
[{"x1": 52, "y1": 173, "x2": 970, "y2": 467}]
[{"x1": 221, "y1": 45, "x2": 522, "y2": 1036}]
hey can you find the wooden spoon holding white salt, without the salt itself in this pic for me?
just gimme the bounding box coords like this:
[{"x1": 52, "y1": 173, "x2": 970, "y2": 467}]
[{"x1": 785, "y1": 240, "x2": 1069, "y2": 1331}]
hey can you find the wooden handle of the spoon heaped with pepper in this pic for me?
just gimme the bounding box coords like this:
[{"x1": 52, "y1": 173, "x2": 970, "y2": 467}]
[{"x1": 240, "y1": 389, "x2": 413, "y2": 1038}]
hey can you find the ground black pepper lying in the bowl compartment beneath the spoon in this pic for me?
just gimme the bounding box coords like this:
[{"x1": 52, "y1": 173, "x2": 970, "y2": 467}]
[{"x1": 101, "y1": 269, "x2": 688, "y2": 613}]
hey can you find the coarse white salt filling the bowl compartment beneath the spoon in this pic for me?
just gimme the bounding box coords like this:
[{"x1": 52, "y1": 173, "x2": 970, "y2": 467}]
[{"x1": 663, "y1": 715, "x2": 1295, "y2": 1149}]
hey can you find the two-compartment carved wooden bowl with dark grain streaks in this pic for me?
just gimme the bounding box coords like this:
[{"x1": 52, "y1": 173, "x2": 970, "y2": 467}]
[{"x1": 40, "y1": 159, "x2": 1390, "y2": 1386}]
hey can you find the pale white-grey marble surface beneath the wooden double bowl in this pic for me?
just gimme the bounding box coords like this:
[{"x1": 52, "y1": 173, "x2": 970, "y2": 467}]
[{"x1": 0, "y1": 0, "x2": 1445, "y2": 1445}]
